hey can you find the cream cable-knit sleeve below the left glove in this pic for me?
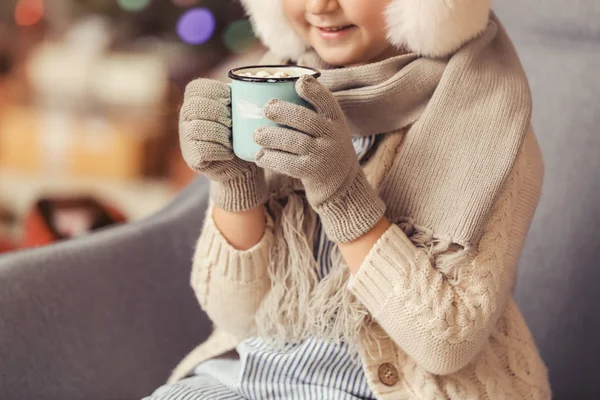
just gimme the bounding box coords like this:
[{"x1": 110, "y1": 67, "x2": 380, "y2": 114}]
[{"x1": 191, "y1": 202, "x2": 273, "y2": 339}]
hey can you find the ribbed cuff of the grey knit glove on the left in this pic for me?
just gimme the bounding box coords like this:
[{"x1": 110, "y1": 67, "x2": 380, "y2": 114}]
[{"x1": 210, "y1": 168, "x2": 269, "y2": 212}]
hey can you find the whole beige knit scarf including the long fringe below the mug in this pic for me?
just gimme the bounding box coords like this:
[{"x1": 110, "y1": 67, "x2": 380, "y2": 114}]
[{"x1": 257, "y1": 14, "x2": 531, "y2": 345}]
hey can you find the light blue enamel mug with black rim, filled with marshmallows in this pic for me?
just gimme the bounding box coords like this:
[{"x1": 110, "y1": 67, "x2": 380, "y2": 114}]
[{"x1": 228, "y1": 65, "x2": 321, "y2": 162}]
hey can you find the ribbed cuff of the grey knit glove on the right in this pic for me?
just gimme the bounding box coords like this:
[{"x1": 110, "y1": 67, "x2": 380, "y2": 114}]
[{"x1": 316, "y1": 170, "x2": 385, "y2": 243}]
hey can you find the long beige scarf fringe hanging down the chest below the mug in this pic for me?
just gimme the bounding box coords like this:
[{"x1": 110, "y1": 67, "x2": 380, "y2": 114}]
[{"x1": 256, "y1": 192, "x2": 380, "y2": 349}]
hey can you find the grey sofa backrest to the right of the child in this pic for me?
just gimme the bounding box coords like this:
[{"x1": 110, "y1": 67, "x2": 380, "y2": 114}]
[{"x1": 495, "y1": 0, "x2": 600, "y2": 399}]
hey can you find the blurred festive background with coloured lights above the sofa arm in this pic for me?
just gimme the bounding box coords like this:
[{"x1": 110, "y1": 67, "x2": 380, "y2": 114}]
[{"x1": 0, "y1": 0, "x2": 263, "y2": 253}]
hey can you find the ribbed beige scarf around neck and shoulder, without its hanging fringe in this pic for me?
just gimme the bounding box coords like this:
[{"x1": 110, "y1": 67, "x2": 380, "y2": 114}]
[{"x1": 269, "y1": 14, "x2": 532, "y2": 248}]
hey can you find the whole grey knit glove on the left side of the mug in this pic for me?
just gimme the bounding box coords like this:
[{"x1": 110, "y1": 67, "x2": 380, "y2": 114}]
[{"x1": 179, "y1": 78, "x2": 268, "y2": 211}]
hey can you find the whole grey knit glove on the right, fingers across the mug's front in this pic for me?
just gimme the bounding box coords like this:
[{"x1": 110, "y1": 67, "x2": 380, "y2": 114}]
[{"x1": 254, "y1": 75, "x2": 385, "y2": 242}]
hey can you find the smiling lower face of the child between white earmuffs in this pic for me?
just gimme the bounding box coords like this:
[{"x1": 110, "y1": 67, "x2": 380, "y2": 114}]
[{"x1": 282, "y1": 0, "x2": 398, "y2": 66}]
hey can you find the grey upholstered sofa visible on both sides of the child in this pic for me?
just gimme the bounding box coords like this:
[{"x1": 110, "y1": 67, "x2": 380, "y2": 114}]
[{"x1": 0, "y1": 0, "x2": 600, "y2": 400}]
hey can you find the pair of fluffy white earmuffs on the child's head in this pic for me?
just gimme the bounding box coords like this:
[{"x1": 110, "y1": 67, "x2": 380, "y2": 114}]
[{"x1": 241, "y1": 0, "x2": 491, "y2": 59}]
